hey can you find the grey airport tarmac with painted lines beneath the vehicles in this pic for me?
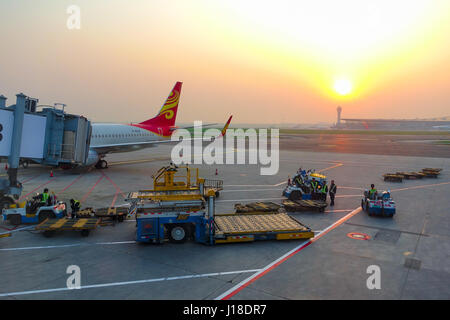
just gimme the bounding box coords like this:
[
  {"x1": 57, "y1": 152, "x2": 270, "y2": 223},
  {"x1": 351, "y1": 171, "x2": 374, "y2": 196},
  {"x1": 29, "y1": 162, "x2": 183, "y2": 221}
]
[{"x1": 0, "y1": 137, "x2": 450, "y2": 300}]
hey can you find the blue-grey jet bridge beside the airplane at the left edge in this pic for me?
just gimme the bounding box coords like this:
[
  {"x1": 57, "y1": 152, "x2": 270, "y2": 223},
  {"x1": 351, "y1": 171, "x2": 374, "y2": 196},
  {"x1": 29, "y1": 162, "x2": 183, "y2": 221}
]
[{"x1": 0, "y1": 93, "x2": 92, "y2": 209}]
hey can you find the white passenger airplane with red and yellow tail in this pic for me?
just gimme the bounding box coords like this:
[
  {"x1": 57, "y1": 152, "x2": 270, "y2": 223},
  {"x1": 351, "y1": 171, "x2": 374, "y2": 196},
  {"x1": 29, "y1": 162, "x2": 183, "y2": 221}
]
[{"x1": 86, "y1": 82, "x2": 232, "y2": 169}]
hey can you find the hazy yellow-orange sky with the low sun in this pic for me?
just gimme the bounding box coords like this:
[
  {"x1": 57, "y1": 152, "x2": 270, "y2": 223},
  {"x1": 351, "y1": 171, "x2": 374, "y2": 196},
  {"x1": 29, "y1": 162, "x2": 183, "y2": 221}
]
[{"x1": 0, "y1": 0, "x2": 450, "y2": 123}]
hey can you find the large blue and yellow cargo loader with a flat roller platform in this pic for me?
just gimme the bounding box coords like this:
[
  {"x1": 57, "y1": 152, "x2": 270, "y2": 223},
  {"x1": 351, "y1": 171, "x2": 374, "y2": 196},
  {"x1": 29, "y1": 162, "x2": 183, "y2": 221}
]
[{"x1": 127, "y1": 165, "x2": 314, "y2": 245}]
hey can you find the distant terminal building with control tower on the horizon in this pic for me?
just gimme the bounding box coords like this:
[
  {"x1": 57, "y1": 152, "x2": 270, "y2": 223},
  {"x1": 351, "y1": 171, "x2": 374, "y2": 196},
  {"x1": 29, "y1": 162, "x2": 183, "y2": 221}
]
[{"x1": 335, "y1": 107, "x2": 450, "y2": 131}]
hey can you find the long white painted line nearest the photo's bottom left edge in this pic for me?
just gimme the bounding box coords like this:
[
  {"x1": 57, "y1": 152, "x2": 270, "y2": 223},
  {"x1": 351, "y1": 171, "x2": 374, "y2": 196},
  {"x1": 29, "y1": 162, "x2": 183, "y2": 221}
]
[{"x1": 0, "y1": 269, "x2": 260, "y2": 297}]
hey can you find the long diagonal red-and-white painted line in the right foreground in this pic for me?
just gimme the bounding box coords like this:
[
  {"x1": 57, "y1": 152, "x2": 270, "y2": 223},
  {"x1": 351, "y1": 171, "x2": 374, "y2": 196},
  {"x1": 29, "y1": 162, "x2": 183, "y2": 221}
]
[{"x1": 216, "y1": 207, "x2": 362, "y2": 300}]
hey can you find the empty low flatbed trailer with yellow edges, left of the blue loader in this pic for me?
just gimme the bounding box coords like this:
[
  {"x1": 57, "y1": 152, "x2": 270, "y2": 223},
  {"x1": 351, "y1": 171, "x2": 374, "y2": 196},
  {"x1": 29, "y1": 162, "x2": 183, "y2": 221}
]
[{"x1": 35, "y1": 218, "x2": 100, "y2": 237}]
